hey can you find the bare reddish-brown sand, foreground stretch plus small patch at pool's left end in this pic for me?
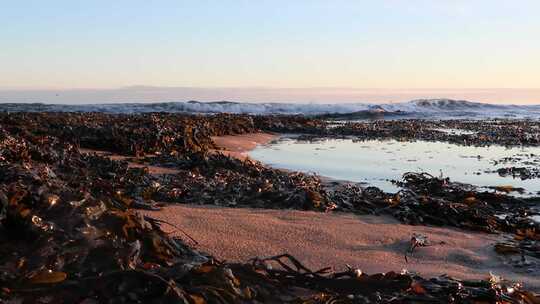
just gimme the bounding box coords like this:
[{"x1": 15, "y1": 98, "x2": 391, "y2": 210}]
[{"x1": 140, "y1": 133, "x2": 540, "y2": 289}]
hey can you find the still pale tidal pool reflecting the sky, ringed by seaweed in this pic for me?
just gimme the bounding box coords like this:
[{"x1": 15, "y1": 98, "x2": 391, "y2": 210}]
[{"x1": 250, "y1": 137, "x2": 540, "y2": 195}]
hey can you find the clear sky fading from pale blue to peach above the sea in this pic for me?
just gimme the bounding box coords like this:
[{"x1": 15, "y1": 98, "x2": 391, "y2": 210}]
[{"x1": 0, "y1": 0, "x2": 540, "y2": 103}]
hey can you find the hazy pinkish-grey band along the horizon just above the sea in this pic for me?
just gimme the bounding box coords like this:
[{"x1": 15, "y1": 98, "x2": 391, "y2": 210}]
[{"x1": 0, "y1": 85, "x2": 540, "y2": 104}]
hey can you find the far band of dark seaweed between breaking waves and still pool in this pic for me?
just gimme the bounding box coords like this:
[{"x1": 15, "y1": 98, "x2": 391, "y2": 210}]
[{"x1": 4, "y1": 112, "x2": 540, "y2": 150}]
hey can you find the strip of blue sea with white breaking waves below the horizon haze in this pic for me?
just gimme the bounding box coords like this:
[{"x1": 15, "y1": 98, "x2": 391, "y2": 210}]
[{"x1": 0, "y1": 99, "x2": 540, "y2": 119}]
